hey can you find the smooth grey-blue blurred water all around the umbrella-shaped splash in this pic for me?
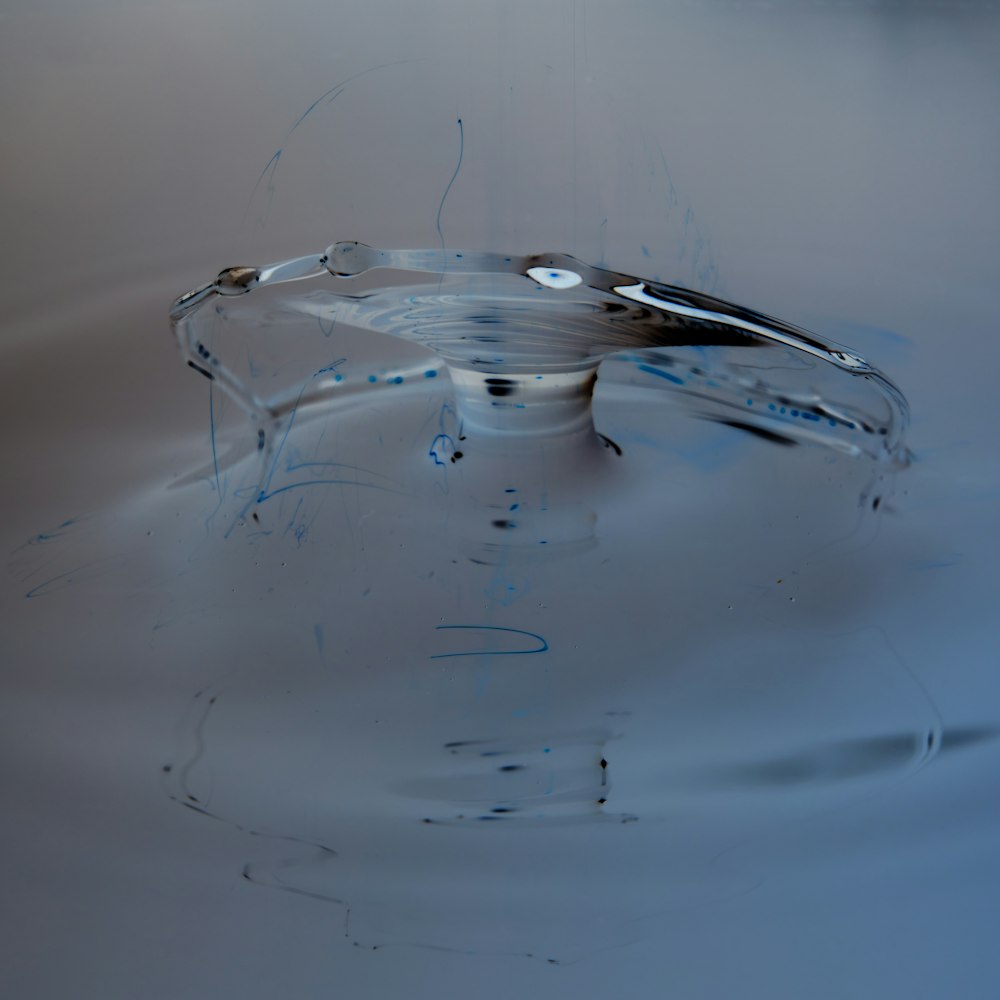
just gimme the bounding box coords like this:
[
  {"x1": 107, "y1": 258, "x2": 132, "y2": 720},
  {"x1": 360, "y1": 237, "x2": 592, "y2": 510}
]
[{"x1": 0, "y1": 3, "x2": 998, "y2": 998}]
